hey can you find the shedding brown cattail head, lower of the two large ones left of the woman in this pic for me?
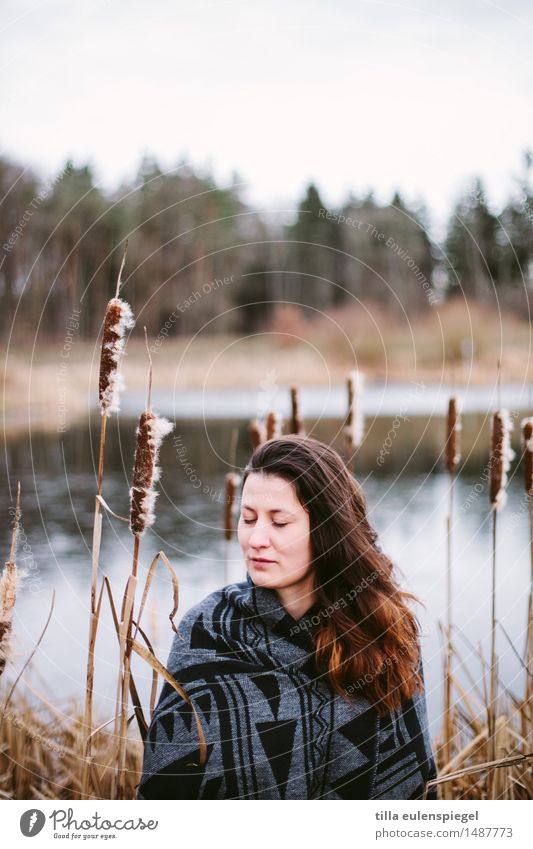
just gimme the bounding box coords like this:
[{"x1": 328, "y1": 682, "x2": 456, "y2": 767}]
[{"x1": 130, "y1": 410, "x2": 174, "y2": 537}]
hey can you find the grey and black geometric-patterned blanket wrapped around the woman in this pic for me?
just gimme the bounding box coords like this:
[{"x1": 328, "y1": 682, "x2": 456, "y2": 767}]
[{"x1": 138, "y1": 576, "x2": 436, "y2": 799}]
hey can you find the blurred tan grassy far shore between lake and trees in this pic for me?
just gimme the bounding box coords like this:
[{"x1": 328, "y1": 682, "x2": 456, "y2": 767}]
[{"x1": 3, "y1": 303, "x2": 533, "y2": 436}]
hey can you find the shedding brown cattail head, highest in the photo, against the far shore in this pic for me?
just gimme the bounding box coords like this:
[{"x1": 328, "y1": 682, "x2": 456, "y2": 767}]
[{"x1": 98, "y1": 298, "x2": 135, "y2": 416}]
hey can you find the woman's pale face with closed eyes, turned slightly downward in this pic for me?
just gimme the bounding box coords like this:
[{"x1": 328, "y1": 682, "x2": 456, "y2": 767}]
[{"x1": 238, "y1": 472, "x2": 313, "y2": 590}]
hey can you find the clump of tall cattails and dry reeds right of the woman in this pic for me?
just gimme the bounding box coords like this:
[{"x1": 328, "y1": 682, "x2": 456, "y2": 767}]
[{"x1": 435, "y1": 388, "x2": 533, "y2": 800}]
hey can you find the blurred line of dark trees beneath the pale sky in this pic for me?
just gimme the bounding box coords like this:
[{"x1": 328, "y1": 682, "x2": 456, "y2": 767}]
[{"x1": 0, "y1": 152, "x2": 533, "y2": 339}]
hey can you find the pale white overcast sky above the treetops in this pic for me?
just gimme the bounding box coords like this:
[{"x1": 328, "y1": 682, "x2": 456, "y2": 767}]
[{"x1": 0, "y1": 0, "x2": 533, "y2": 237}]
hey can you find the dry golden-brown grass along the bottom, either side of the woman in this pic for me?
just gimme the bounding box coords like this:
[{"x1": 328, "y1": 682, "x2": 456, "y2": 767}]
[{"x1": 0, "y1": 640, "x2": 533, "y2": 800}]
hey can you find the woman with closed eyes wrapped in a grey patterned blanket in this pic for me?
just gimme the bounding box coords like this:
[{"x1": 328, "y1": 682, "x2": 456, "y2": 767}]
[{"x1": 139, "y1": 436, "x2": 436, "y2": 799}]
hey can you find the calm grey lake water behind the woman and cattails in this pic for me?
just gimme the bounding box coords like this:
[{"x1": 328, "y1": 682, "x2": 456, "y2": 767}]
[{"x1": 0, "y1": 390, "x2": 530, "y2": 733}]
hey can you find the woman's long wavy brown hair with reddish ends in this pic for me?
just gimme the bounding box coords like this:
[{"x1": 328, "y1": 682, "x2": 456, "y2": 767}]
[{"x1": 243, "y1": 435, "x2": 423, "y2": 713}]
